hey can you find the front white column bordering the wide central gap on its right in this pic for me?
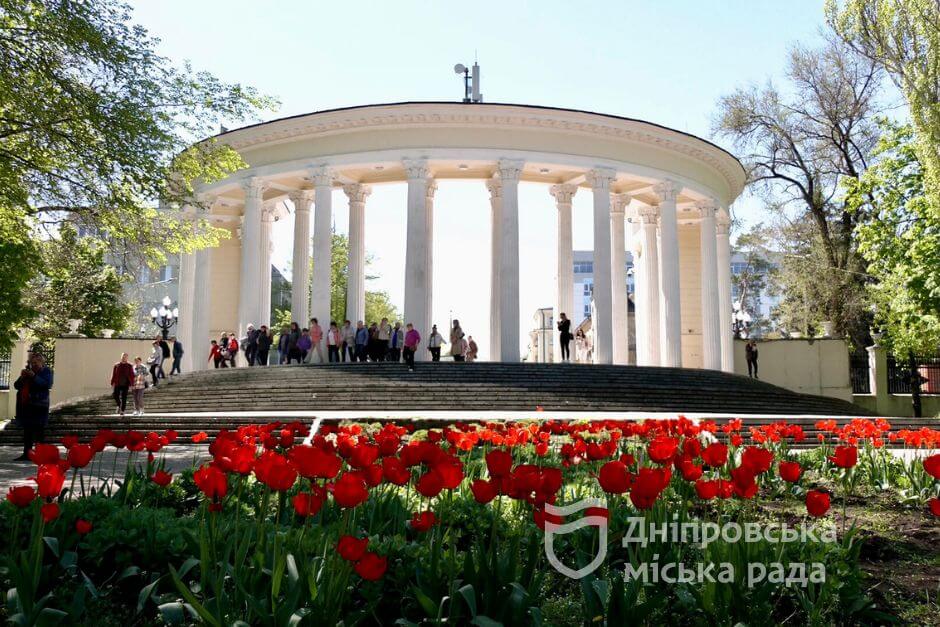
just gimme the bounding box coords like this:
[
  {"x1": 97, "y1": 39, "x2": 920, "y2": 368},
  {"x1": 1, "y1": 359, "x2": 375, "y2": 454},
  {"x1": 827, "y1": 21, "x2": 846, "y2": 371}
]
[{"x1": 497, "y1": 159, "x2": 523, "y2": 363}]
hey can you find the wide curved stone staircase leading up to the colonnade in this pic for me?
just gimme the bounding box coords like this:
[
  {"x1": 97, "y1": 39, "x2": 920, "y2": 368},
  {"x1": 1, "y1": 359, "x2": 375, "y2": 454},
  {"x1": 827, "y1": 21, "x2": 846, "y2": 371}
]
[{"x1": 0, "y1": 362, "x2": 900, "y2": 445}]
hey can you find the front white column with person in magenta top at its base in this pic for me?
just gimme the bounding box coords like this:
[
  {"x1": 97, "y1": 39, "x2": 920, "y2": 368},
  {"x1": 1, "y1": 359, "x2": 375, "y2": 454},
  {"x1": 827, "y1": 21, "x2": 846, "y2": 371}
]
[{"x1": 403, "y1": 159, "x2": 431, "y2": 361}]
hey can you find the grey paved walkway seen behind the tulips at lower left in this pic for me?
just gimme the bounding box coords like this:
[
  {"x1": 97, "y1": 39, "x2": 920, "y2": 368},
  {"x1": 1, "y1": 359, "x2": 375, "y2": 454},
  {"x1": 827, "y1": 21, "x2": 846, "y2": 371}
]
[{"x1": 0, "y1": 443, "x2": 209, "y2": 498}]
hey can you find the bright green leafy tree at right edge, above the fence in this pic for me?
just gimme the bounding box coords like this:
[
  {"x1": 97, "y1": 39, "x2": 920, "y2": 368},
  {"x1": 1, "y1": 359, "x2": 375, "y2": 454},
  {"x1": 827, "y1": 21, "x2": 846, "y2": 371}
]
[{"x1": 847, "y1": 120, "x2": 940, "y2": 357}]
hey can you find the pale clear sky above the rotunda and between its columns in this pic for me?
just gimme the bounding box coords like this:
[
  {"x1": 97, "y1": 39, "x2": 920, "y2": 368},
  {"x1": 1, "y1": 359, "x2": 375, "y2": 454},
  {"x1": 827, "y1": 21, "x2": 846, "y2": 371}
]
[{"x1": 132, "y1": 0, "x2": 823, "y2": 355}]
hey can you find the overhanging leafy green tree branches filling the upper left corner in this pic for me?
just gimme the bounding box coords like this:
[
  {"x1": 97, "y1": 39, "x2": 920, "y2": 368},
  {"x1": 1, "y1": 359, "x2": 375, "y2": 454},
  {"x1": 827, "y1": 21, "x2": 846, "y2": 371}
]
[{"x1": 0, "y1": 0, "x2": 274, "y2": 344}]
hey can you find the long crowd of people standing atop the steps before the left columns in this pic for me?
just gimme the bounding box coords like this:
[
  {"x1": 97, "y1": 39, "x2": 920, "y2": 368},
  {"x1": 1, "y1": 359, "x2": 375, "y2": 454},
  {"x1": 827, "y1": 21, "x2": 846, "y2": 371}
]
[{"x1": 208, "y1": 318, "x2": 479, "y2": 369}]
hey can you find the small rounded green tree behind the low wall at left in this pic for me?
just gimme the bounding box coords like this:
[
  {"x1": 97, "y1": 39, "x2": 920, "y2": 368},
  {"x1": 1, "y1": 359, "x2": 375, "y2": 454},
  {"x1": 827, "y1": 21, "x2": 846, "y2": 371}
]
[{"x1": 24, "y1": 225, "x2": 133, "y2": 343}]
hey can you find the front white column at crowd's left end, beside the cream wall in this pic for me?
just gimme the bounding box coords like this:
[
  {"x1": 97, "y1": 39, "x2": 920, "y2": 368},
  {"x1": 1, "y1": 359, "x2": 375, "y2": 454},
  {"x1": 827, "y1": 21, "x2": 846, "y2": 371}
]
[{"x1": 239, "y1": 176, "x2": 264, "y2": 341}]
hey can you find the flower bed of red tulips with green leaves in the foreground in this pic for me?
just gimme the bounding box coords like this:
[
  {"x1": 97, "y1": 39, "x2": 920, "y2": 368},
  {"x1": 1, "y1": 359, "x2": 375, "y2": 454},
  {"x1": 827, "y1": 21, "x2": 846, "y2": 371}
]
[{"x1": 0, "y1": 418, "x2": 940, "y2": 625}]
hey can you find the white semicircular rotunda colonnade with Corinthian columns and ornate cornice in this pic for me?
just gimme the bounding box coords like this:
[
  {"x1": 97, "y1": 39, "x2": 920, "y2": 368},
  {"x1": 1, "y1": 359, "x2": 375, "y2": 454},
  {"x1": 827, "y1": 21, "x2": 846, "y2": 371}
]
[{"x1": 178, "y1": 102, "x2": 745, "y2": 372}]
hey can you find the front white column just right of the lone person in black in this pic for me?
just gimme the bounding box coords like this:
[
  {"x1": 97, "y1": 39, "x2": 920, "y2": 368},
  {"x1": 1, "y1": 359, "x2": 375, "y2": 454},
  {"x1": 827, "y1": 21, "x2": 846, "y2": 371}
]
[{"x1": 586, "y1": 168, "x2": 615, "y2": 364}]
